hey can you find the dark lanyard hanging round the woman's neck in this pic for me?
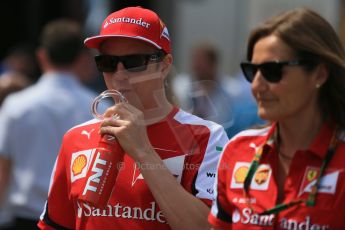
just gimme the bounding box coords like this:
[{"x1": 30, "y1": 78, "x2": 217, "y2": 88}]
[{"x1": 243, "y1": 125, "x2": 339, "y2": 215}]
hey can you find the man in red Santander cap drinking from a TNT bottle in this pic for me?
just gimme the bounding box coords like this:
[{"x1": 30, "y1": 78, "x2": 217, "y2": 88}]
[{"x1": 39, "y1": 7, "x2": 228, "y2": 229}]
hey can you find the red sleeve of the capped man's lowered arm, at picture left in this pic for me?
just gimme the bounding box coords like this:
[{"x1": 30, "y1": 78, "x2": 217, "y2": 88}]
[{"x1": 38, "y1": 137, "x2": 75, "y2": 230}]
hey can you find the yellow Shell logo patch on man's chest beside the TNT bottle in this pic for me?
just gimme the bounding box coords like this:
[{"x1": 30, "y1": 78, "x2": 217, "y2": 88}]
[{"x1": 70, "y1": 149, "x2": 95, "y2": 182}]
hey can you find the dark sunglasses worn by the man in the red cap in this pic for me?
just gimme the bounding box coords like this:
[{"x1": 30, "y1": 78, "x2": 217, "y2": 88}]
[{"x1": 95, "y1": 52, "x2": 164, "y2": 73}]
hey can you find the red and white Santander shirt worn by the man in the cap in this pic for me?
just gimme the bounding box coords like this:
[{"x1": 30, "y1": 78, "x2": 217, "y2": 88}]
[{"x1": 39, "y1": 108, "x2": 228, "y2": 229}]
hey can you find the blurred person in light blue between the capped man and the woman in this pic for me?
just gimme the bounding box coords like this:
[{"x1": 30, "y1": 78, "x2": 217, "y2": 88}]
[{"x1": 172, "y1": 42, "x2": 262, "y2": 138}]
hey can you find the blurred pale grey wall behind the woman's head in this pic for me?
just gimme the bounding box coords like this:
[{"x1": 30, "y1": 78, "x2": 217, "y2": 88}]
[{"x1": 173, "y1": 0, "x2": 340, "y2": 75}]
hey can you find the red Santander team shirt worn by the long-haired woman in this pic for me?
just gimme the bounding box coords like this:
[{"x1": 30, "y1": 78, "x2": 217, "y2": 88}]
[{"x1": 209, "y1": 123, "x2": 345, "y2": 230}]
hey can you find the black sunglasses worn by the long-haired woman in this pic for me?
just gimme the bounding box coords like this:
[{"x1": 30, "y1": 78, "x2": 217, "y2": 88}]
[{"x1": 241, "y1": 60, "x2": 305, "y2": 83}]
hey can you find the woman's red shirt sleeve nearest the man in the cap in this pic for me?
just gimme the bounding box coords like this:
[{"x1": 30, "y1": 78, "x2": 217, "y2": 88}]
[{"x1": 208, "y1": 142, "x2": 232, "y2": 229}]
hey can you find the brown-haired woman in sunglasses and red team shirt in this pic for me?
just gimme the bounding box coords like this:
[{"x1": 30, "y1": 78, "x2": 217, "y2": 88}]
[{"x1": 209, "y1": 8, "x2": 345, "y2": 229}]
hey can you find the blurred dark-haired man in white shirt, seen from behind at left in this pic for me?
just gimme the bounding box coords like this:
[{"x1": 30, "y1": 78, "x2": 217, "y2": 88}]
[{"x1": 0, "y1": 19, "x2": 96, "y2": 229}]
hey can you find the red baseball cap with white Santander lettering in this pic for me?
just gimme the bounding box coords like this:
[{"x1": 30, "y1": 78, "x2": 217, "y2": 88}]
[{"x1": 84, "y1": 7, "x2": 171, "y2": 53}]
